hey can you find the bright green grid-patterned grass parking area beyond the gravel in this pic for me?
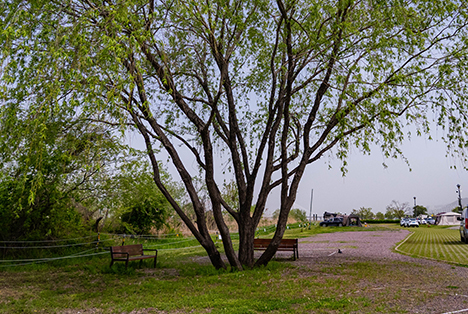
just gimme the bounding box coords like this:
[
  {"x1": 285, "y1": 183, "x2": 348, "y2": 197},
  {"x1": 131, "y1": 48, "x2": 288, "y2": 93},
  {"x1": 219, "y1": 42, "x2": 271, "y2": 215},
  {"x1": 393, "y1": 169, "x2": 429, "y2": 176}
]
[{"x1": 397, "y1": 226, "x2": 468, "y2": 266}]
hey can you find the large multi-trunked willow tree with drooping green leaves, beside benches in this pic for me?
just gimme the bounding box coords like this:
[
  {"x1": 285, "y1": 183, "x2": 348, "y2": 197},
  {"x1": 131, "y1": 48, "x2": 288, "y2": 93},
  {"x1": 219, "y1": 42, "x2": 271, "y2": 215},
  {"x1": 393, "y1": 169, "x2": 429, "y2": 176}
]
[{"x1": 0, "y1": 0, "x2": 468, "y2": 269}]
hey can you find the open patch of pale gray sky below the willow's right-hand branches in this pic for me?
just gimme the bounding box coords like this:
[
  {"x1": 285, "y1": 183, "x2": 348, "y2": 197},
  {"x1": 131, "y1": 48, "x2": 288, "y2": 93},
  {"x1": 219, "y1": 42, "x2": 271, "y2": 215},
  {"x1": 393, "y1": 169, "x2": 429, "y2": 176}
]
[{"x1": 286, "y1": 138, "x2": 468, "y2": 215}]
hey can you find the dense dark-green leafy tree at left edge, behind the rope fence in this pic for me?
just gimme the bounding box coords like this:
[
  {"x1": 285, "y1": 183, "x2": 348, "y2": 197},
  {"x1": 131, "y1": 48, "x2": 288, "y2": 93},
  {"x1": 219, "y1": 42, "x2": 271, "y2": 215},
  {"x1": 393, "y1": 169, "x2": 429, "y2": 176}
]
[{"x1": 0, "y1": 113, "x2": 124, "y2": 241}]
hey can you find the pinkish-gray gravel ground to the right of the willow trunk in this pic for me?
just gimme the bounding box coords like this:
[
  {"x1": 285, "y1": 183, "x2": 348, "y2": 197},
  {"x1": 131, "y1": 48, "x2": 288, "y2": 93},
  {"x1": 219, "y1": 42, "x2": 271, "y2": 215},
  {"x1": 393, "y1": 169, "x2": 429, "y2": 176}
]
[{"x1": 266, "y1": 230, "x2": 468, "y2": 313}]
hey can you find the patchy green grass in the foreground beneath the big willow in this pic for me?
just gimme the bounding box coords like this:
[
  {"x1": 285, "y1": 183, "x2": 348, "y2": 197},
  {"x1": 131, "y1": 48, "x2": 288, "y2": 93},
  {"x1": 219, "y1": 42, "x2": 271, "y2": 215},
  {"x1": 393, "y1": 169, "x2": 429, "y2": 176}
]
[{"x1": 0, "y1": 253, "x2": 455, "y2": 313}]
